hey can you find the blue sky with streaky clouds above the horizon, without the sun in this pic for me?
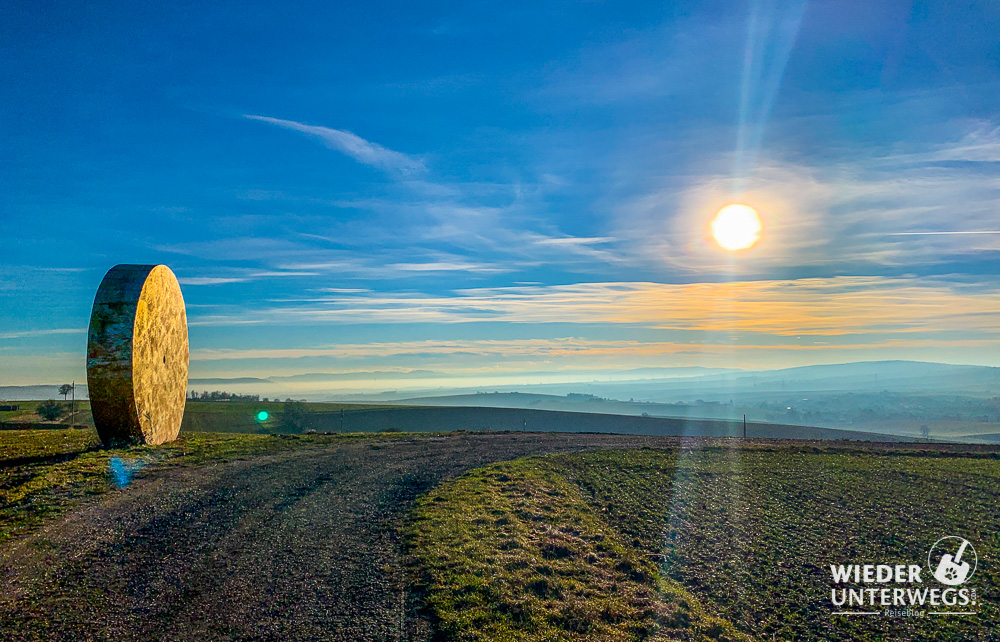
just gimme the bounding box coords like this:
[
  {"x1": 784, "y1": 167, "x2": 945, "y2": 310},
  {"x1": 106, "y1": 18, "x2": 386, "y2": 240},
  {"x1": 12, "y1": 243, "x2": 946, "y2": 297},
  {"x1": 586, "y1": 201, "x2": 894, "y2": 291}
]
[{"x1": 0, "y1": 0, "x2": 1000, "y2": 393}]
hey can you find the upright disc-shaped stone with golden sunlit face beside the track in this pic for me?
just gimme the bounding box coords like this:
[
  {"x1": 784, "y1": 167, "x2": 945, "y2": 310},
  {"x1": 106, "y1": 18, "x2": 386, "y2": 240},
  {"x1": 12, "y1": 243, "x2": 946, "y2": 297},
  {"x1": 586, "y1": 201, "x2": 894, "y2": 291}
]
[{"x1": 87, "y1": 265, "x2": 188, "y2": 446}]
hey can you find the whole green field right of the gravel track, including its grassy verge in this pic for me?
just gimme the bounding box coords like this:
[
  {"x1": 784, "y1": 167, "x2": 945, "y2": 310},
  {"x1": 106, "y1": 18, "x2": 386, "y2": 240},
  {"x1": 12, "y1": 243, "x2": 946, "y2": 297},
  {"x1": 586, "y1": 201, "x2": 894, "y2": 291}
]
[{"x1": 408, "y1": 447, "x2": 1000, "y2": 640}]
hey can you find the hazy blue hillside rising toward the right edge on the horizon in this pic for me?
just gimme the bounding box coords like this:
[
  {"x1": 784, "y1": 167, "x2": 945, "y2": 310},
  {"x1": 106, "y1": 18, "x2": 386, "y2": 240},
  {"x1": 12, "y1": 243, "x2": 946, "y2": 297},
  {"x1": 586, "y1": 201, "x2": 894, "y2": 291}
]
[{"x1": 394, "y1": 361, "x2": 1000, "y2": 439}]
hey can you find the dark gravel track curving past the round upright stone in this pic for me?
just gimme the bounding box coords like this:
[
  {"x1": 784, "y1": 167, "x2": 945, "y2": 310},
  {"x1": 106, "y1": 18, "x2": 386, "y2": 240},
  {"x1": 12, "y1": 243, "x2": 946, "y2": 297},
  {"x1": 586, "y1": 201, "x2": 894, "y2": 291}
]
[{"x1": 0, "y1": 433, "x2": 692, "y2": 640}]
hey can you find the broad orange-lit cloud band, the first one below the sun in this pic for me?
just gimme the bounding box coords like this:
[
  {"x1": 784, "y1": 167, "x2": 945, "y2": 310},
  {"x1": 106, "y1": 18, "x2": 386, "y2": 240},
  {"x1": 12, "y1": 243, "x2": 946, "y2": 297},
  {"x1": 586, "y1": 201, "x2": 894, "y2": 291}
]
[{"x1": 189, "y1": 276, "x2": 1000, "y2": 341}]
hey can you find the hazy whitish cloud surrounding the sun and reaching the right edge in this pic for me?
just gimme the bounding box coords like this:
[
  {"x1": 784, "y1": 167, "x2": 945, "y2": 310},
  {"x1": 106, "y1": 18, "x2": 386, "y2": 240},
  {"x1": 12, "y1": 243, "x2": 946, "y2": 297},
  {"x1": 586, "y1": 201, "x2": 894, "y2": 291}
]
[{"x1": 614, "y1": 132, "x2": 1000, "y2": 275}]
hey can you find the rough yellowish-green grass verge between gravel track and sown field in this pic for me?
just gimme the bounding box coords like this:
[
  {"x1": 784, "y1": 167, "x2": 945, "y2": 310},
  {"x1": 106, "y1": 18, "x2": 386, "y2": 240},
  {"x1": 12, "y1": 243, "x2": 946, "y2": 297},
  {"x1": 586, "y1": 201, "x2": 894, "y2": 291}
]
[{"x1": 408, "y1": 458, "x2": 748, "y2": 641}]
